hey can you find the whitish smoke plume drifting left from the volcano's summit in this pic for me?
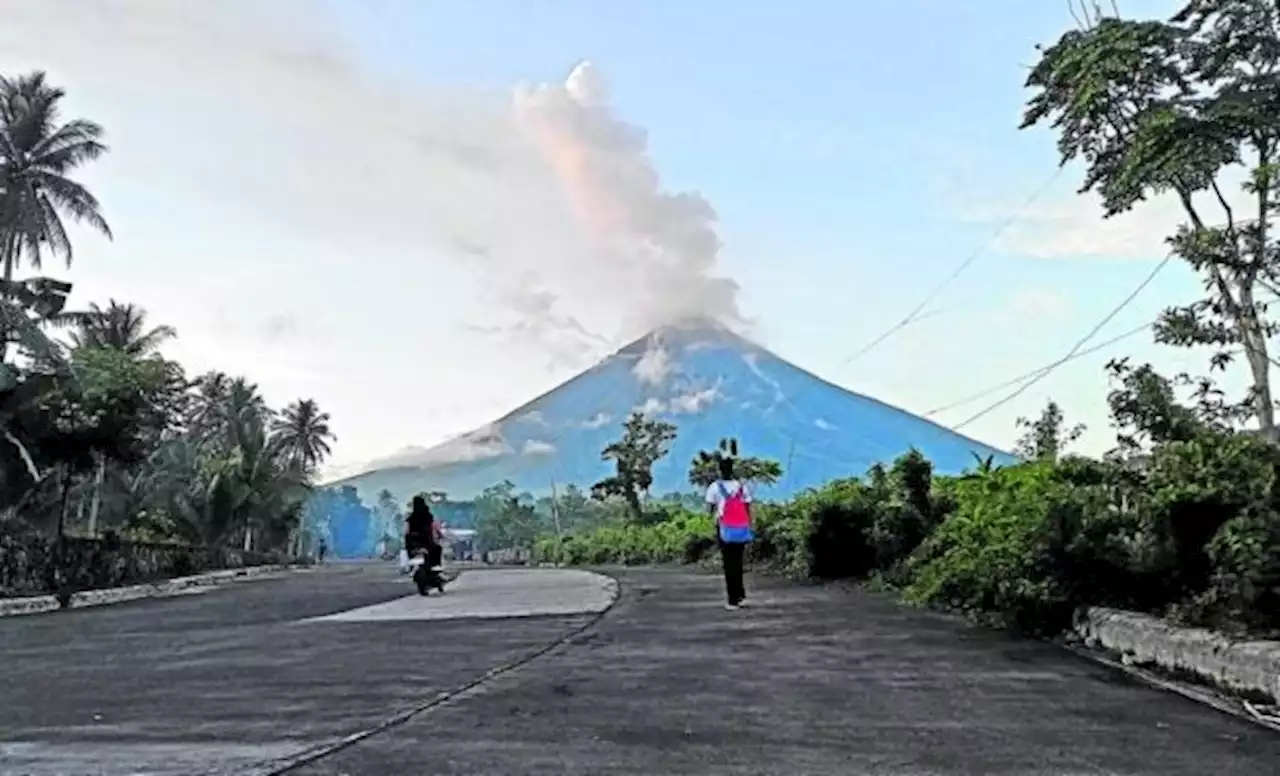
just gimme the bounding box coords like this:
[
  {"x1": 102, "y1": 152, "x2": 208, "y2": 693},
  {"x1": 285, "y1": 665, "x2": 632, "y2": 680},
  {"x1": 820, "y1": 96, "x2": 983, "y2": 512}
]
[{"x1": 0, "y1": 0, "x2": 742, "y2": 365}]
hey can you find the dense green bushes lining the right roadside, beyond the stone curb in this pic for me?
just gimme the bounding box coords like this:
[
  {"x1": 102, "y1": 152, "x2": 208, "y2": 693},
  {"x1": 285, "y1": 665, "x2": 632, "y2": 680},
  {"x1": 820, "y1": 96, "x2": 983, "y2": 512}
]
[{"x1": 536, "y1": 430, "x2": 1280, "y2": 634}]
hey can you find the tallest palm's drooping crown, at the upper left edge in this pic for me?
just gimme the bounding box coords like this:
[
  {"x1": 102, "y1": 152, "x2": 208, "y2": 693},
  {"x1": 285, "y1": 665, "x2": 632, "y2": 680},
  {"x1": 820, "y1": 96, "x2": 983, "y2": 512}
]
[{"x1": 0, "y1": 72, "x2": 111, "y2": 364}]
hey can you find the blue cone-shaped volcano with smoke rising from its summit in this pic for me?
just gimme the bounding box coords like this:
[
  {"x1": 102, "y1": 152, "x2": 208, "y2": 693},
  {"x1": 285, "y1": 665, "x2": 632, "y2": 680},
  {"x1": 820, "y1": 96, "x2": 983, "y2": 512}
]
[{"x1": 334, "y1": 323, "x2": 1015, "y2": 503}]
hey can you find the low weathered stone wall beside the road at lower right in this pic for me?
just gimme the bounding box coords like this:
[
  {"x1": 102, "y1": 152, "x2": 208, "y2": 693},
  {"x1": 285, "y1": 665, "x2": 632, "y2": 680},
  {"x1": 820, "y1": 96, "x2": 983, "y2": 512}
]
[{"x1": 1075, "y1": 607, "x2": 1280, "y2": 703}]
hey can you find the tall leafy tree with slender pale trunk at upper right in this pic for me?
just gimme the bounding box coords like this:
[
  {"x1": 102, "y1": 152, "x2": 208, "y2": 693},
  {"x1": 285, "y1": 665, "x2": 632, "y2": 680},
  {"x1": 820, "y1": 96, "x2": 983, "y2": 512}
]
[{"x1": 1023, "y1": 0, "x2": 1280, "y2": 439}]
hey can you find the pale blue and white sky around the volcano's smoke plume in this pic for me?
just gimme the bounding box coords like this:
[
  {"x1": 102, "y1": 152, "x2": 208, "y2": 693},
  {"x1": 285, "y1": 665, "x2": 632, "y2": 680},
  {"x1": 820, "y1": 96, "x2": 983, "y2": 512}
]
[{"x1": 0, "y1": 0, "x2": 1228, "y2": 473}]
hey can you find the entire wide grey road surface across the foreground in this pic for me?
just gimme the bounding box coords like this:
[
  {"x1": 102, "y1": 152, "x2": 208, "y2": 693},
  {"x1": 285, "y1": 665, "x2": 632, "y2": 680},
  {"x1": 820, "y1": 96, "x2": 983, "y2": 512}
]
[{"x1": 0, "y1": 566, "x2": 1280, "y2": 776}]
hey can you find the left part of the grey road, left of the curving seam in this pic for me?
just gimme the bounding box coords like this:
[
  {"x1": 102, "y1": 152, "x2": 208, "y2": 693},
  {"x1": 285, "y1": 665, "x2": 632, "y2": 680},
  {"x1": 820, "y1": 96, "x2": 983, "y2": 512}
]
[{"x1": 0, "y1": 563, "x2": 599, "y2": 776}]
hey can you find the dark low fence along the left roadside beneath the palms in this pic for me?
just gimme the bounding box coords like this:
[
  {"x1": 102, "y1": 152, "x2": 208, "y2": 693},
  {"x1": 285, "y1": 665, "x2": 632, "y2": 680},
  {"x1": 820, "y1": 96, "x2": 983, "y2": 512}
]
[{"x1": 0, "y1": 528, "x2": 284, "y2": 598}]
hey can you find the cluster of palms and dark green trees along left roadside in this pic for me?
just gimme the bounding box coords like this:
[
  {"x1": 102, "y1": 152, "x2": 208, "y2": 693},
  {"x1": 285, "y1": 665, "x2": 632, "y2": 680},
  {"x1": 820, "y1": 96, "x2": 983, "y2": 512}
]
[{"x1": 0, "y1": 73, "x2": 333, "y2": 594}]
